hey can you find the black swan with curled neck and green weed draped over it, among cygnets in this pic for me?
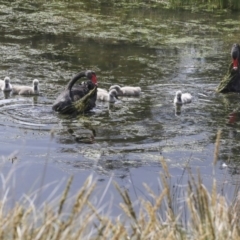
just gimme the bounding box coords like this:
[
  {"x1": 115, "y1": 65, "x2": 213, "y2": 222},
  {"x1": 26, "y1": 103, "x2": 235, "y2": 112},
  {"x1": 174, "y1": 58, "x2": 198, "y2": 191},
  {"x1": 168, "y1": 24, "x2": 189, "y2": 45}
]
[{"x1": 52, "y1": 70, "x2": 97, "y2": 113}]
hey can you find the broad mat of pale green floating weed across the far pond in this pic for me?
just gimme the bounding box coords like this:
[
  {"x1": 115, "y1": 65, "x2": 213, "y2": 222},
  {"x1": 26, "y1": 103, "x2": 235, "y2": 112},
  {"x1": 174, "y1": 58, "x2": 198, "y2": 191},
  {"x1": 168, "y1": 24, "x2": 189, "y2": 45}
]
[{"x1": 0, "y1": 1, "x2": 236, "y2": 50}]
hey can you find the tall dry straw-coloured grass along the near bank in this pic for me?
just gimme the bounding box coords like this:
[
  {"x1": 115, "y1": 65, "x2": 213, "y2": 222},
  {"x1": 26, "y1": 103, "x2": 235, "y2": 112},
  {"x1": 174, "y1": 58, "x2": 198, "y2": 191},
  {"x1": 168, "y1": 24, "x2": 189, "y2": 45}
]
[{"x1": 0, "y1": 132, "x2": 240, "y2": 240}]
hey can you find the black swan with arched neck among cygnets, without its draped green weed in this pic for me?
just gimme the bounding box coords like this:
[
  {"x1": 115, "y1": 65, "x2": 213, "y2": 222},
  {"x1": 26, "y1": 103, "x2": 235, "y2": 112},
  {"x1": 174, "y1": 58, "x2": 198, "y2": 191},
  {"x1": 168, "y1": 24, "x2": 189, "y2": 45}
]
[{"x1": 52, "y1": 70, "x2": 97, "y2": 113}]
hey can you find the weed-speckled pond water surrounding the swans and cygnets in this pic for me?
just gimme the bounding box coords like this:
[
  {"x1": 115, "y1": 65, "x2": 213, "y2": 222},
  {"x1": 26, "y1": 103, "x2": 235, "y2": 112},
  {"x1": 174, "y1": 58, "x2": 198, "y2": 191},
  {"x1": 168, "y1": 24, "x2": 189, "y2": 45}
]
[{"x1": 0, "y1": 1, "x2": 240, "y2": 216}]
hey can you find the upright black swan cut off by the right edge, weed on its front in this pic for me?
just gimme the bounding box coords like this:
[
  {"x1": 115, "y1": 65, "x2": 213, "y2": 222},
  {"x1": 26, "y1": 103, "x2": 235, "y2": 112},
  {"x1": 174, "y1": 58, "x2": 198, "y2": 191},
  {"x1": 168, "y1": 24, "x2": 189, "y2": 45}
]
[{"x1": 216, "y1": 43, "x2": 240, "y2": 93}]
